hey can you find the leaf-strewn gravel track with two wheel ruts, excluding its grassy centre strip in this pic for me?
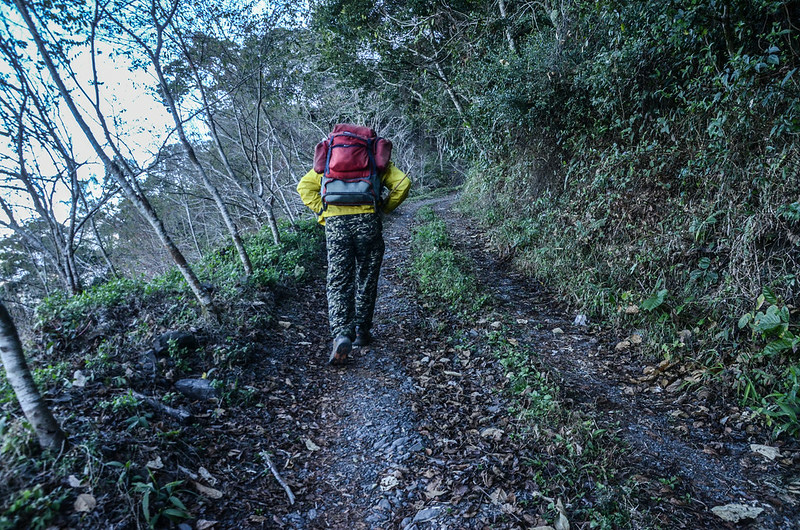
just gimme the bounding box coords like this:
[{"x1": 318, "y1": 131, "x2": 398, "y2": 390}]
[{"x1": 245, "y1": 197, "x2": 800, "y2": 530}]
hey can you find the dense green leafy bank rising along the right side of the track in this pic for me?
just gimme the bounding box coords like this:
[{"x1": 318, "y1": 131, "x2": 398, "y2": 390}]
[{"x1": 316, "y1": 0, "x2": 800, "y2": 430}]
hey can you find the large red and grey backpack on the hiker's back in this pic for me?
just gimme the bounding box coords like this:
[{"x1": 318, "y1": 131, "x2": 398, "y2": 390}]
[{"x1": 314, "y1": 123, "x2": 392, "y2": 208}]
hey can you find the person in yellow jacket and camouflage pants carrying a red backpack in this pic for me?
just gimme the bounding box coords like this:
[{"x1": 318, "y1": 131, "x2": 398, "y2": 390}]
[{"x1": 297, "y1": 124, "x2": 411, "y2": 365}]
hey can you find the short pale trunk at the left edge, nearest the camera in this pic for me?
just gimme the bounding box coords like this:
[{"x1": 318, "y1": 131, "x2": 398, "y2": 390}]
[{"x1": 0, "y1": 302, "x2": 67, "y2": 451}]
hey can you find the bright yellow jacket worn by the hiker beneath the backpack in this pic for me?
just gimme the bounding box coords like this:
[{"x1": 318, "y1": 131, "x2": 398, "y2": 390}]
[{"x1": 297, "y1": 162, "x2": 411, "y2": 225}]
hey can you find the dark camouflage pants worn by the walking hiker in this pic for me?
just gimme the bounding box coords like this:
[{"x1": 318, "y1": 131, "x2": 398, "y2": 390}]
[{"x1": 325, "y1": 214, "x2": 385, "y2": 340}]
